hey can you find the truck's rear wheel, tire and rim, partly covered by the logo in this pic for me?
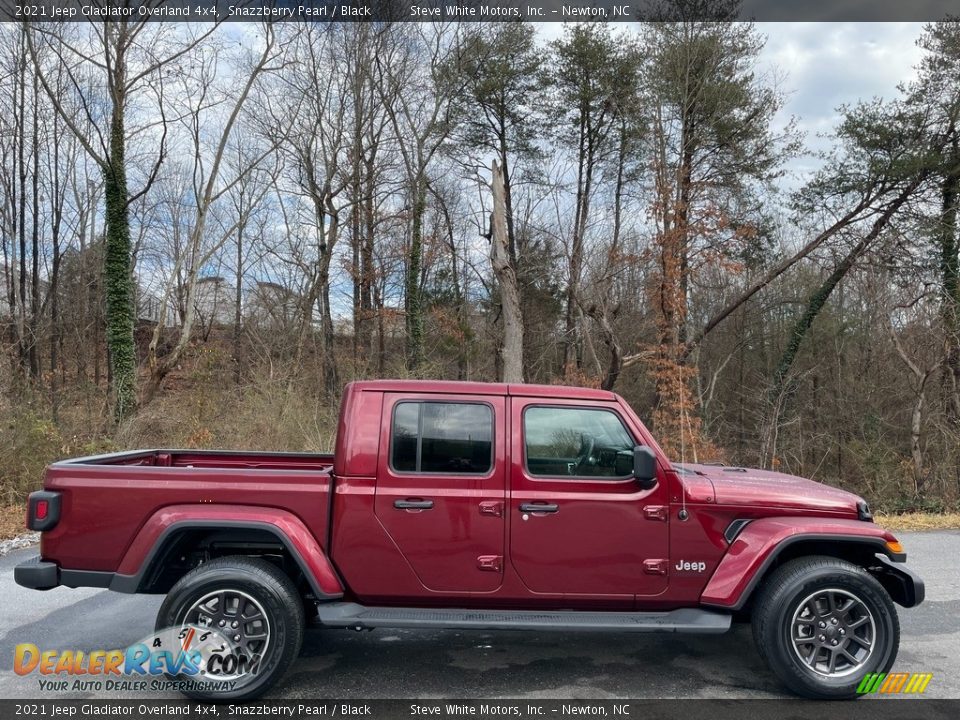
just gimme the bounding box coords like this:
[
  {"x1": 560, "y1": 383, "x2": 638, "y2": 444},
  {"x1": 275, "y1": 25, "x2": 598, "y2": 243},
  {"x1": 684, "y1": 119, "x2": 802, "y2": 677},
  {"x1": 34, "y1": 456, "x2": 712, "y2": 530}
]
[{"x1": 156, "y1": 556, "x2": 304, "y2": 701}]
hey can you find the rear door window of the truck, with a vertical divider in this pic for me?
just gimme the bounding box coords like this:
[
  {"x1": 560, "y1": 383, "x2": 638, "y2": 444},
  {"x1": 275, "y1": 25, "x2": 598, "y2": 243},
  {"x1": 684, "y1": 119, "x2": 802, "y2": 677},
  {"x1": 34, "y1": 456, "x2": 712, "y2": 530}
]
[{"x1": 391, "y1": 402, "x2": 493, "y2": 474}]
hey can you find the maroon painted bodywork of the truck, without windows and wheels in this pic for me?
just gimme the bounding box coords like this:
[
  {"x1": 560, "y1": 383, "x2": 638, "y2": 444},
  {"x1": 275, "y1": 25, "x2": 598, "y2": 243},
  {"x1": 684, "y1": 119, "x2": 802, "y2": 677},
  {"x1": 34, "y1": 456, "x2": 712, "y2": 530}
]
[{"x1": 26, "y1": 380, "x2": 893, "y2": 609}]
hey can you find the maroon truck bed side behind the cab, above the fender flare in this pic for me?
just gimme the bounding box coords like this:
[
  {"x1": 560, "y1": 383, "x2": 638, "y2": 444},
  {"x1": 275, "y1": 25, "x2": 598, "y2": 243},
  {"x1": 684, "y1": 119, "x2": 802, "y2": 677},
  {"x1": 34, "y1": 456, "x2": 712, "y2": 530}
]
[{"x1": 41, "y1": 449, "x2": 333, "y2": 572}]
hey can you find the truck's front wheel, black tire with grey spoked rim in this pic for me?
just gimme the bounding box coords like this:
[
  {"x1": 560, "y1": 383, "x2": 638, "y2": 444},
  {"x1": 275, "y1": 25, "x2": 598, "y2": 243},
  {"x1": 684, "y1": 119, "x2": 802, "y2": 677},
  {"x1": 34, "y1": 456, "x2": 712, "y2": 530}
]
[{"x1": 752, "y1": 556, "x2": 900, "y2": 700}]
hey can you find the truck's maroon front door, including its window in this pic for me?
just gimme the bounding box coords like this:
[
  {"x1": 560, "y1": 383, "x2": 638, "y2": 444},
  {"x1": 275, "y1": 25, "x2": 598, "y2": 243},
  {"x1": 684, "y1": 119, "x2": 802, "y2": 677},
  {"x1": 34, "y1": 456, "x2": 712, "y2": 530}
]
[{"x1": 509, "y1": 397, "x2": 669, "y2": 603}]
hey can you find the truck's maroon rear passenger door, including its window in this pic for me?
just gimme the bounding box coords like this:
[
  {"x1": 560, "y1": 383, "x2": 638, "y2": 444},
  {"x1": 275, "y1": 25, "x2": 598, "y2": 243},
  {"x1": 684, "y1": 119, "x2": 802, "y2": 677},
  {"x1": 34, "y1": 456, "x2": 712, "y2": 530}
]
[{"x1": 375, "y1": 393, "x2": 506, "y2": 592}]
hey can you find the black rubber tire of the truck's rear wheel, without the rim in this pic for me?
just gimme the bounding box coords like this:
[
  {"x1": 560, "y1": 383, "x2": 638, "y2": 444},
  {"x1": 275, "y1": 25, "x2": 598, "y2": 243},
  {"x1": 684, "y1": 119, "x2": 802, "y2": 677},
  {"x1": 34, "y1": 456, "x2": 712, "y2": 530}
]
[{"x1": 156, "y1": 555, "x2": 304, "y2": 701}]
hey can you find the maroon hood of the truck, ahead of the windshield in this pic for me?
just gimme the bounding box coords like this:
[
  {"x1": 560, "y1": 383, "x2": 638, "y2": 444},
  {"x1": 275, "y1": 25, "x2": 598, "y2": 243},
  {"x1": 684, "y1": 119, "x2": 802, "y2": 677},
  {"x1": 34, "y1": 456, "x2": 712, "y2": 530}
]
[{"x1": 675, "y1": 463, "x2": 866, "y2": 517}]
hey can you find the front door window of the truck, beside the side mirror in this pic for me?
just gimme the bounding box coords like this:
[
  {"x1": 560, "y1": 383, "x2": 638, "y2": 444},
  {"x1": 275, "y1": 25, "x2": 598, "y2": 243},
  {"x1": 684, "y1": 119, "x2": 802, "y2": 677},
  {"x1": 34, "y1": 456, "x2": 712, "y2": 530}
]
[{"x1": 523, "y1": 407, "x2": 634, "y2": 477}]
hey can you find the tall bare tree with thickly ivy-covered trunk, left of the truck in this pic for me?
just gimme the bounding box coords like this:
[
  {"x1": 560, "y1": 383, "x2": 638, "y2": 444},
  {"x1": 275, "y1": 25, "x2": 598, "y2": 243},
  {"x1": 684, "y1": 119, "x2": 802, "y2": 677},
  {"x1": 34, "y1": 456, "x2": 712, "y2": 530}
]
[{"x1": 27, "y1": 18, "x2": 216, "y2": 421}]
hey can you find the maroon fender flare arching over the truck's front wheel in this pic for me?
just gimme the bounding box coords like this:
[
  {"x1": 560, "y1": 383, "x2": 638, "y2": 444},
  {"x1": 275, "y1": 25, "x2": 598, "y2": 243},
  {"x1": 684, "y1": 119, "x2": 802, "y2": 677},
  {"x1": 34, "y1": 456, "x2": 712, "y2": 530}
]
[{"x1": 700, "y1": 517, "x2": 900, "y2": 610}]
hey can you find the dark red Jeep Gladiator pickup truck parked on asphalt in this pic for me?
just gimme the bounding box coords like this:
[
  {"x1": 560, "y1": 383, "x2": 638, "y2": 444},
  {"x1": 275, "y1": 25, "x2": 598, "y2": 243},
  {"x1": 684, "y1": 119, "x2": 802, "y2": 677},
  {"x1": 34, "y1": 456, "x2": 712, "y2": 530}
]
[{"x1": 16, "y1": 381, "x2": 924, "y2": 700}]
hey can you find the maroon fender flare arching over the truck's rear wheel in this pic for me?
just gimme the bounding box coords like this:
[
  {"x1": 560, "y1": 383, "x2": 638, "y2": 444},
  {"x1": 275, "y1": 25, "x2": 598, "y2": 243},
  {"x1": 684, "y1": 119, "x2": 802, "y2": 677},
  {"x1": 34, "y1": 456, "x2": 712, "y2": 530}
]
[{"x1": 109, "y1": 505, "x2": 343, "y2": 599}]
